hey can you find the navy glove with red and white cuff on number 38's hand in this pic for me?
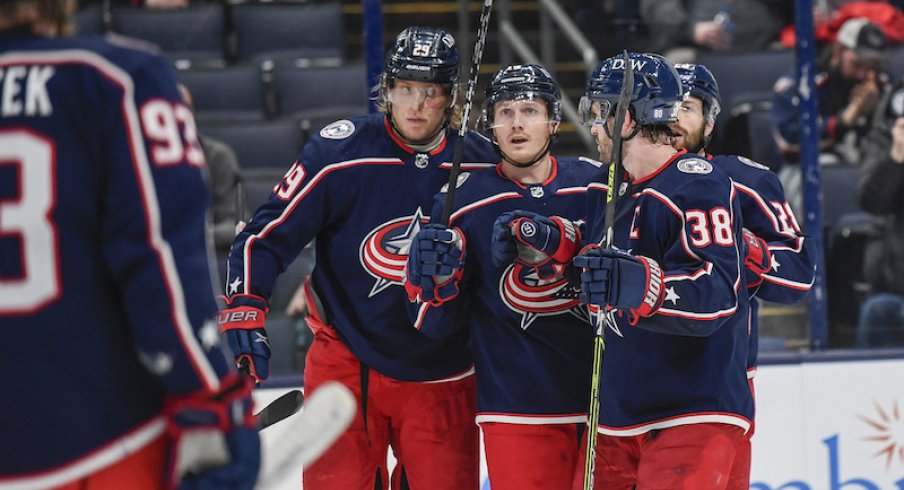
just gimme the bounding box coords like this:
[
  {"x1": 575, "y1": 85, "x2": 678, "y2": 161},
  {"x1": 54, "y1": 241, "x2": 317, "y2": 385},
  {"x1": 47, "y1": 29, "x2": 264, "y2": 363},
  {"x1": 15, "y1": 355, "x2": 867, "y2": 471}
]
[{"x1": 574, "y1": 245, "x2": 664, "y2": 325}]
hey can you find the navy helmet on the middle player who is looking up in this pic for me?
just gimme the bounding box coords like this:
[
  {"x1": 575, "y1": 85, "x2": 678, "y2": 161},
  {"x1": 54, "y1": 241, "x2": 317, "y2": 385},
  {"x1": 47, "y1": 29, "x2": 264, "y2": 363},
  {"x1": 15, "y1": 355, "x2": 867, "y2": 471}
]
[{"x1": 483, "y1": 65, "x2": 562, "y2": 127}]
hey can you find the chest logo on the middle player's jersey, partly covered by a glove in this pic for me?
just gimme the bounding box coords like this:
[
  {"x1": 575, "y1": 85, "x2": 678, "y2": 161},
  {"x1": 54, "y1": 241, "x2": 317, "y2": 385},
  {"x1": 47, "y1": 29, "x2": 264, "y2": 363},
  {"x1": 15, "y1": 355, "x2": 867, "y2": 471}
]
[{"x1": 499, "y1": 263, "x2": 590, "y2": 330}]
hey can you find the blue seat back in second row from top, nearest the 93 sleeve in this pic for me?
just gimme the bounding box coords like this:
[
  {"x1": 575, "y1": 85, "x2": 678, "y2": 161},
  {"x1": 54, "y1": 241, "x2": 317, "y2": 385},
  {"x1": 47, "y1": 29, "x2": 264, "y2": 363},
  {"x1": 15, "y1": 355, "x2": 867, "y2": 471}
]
[{"x1": 177, "y1": 65, "x2": 267, "y2": 123}]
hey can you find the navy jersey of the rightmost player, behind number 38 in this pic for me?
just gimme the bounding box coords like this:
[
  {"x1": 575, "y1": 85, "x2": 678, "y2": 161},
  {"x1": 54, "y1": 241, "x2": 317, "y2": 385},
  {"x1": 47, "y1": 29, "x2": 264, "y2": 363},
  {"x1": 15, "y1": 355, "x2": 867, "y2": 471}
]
[{"x1": 709, "y1": 155, "x2": 816, "y2": 377}]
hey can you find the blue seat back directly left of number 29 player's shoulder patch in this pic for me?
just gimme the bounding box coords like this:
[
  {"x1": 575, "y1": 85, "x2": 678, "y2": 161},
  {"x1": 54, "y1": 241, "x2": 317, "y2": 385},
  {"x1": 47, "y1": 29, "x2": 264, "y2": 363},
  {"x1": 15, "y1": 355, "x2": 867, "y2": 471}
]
[{"x1": 200, "y1": 118, "x2": 304, "y2": 172}]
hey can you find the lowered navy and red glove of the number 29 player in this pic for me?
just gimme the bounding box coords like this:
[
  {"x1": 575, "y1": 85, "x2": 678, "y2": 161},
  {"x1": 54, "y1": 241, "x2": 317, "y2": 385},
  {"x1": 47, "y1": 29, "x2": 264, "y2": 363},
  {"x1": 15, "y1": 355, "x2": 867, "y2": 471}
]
[{"x1": 219, "y1": 294, "x2": 270, "y2": 383}]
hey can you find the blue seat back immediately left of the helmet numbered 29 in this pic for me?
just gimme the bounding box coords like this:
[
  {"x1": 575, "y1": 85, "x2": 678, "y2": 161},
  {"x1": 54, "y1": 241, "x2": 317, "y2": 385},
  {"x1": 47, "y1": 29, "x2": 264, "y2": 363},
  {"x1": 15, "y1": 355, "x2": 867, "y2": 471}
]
[{"x1": 273, "y1": 64, "x2": 369, "y2": 117}]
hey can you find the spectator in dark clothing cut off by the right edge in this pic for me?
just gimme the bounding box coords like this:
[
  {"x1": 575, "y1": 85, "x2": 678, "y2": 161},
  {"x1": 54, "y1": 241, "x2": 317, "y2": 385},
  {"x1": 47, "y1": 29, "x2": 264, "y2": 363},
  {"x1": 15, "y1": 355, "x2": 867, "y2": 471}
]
[{"x1": 857, "y1": 79, "x2": 904, "y2": 347}]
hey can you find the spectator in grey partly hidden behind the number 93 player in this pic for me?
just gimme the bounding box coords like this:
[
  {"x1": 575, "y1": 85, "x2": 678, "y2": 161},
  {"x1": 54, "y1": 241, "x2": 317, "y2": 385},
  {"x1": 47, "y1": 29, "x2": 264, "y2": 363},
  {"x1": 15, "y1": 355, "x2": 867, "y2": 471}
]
[{"x1": 179, "y1": 83, "x2": 241, "y2": 262}]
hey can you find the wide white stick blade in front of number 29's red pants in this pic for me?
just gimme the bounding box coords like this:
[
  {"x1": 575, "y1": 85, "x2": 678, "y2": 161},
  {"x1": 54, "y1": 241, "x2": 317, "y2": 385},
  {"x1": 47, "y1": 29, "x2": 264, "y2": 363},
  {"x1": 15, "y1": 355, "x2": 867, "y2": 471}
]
[{"x1": 257, "y1": 381, "x2": 358, "y2": 488}]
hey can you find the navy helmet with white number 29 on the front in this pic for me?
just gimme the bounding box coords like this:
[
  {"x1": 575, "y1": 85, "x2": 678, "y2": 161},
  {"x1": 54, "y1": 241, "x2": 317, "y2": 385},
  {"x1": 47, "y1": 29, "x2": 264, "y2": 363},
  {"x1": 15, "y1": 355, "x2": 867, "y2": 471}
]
[{"x1": 384, "y1": 27, "x2": 461, "y2": 85}]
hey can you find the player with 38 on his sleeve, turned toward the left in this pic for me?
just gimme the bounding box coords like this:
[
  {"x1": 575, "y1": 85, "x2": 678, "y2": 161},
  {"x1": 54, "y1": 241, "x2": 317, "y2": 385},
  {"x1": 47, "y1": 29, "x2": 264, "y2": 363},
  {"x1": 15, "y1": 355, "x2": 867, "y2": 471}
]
[{"x1": 574, "y1": 54, "x2": 753, "y2": 490}]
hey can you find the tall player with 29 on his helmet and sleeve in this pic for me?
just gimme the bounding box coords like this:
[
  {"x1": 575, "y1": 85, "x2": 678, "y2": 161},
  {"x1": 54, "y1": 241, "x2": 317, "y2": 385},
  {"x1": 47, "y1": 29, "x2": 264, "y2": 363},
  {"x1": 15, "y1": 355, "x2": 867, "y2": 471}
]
[{"x1": 221, "y1": 27, "x2": 495, "y2": 490}]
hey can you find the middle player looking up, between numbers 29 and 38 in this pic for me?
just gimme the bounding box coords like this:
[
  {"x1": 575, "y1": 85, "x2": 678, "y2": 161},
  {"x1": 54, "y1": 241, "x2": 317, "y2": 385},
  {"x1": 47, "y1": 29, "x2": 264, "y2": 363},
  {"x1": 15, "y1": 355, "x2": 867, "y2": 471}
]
[{"x1": 406, "y1": 65, "x2": 599, "y2": 490}]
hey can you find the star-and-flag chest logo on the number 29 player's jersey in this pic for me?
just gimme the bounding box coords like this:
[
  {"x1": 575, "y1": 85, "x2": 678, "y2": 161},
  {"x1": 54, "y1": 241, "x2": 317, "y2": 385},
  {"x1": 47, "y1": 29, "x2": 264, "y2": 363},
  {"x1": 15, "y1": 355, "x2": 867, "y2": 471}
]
[{"x1": 358, "y1": 208, "x2": 430, "y2": 298}]
